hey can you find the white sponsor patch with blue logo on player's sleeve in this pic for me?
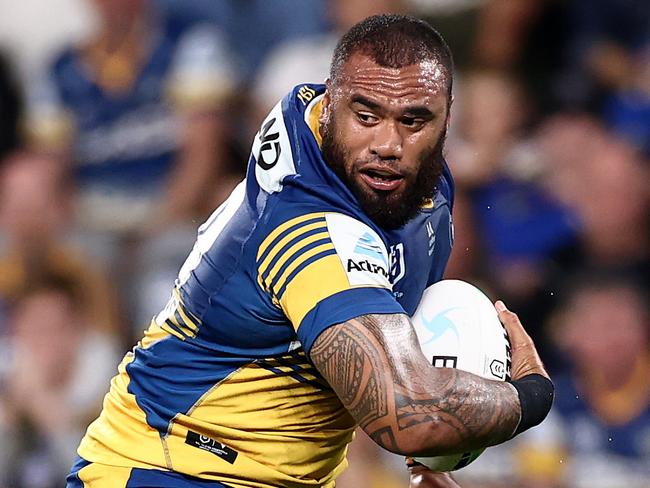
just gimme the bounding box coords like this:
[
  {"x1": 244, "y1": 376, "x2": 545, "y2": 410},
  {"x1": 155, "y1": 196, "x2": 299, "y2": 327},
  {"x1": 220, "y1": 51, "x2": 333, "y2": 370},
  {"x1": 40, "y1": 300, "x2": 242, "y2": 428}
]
[{"x1": 325, "y1": 214, "x2": 391, "y2": 289}]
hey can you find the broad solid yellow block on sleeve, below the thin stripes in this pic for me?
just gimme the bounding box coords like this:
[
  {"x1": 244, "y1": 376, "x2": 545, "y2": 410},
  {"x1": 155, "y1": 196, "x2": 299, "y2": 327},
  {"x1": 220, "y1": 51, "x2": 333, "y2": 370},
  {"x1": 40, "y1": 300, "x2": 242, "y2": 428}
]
[{"x1": 280, "y1": 254, "x2": 351, "y2": 329}]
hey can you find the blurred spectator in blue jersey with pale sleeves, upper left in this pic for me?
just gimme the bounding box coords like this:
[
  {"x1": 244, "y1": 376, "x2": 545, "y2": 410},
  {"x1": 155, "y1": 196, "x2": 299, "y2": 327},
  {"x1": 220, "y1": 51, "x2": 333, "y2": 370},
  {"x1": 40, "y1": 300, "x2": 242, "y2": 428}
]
[{"x1": 24, "y1": 0, "x2": 238, "y2": 332}]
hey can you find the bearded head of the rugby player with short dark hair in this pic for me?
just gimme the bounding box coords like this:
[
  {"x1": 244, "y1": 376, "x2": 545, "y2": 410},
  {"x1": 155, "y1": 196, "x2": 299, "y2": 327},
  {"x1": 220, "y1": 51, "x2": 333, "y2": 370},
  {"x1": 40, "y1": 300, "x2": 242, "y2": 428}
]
[{"x1": 320, "y1": 15, "x2": 453, "y2": 229}]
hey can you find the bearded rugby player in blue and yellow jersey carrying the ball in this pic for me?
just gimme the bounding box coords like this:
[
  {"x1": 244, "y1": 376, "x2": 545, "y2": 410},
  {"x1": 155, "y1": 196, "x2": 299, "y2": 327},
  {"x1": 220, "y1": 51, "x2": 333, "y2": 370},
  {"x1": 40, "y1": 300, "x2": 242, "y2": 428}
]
[{"x1": 68, "y1": 15, "x2": 553, "y2": 488}]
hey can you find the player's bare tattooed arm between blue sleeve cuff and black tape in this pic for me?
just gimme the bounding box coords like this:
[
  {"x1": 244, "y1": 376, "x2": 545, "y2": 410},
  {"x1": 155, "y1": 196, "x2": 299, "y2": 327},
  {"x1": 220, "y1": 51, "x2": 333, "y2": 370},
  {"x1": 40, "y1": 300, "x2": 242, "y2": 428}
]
[{"x1": 310, "y1": 314, "x2": 520, "y2": 456}]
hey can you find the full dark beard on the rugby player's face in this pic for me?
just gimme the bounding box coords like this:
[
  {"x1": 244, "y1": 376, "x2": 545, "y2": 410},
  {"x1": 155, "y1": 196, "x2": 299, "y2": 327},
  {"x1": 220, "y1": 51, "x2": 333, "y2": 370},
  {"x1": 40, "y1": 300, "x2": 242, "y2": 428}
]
[{"x1": 321, "y1": 117, "x2": 446, "y2": 230}]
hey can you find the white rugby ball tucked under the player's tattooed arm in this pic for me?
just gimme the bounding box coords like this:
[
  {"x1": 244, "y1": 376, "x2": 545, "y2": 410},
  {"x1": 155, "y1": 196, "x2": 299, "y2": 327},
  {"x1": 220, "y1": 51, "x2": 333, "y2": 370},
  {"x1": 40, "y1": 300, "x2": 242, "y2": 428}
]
[{"x1": 411, "y1": 280, "x2": 510, "y2": 471}]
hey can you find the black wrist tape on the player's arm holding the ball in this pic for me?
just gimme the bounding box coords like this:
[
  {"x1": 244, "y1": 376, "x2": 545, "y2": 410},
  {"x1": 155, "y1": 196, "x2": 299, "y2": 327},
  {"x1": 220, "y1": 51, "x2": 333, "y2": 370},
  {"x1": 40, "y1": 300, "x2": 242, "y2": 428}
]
[{"x1": 511, "y1": 374, "x2": 555, "y2": 437}]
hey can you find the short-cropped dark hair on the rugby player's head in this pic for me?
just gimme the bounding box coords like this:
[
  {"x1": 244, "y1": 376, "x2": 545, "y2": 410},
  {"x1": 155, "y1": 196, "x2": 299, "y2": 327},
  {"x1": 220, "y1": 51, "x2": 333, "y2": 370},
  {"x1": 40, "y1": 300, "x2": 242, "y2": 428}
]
[{"x1": 330, "y1": 14, "x2": 454, "y2": 95}]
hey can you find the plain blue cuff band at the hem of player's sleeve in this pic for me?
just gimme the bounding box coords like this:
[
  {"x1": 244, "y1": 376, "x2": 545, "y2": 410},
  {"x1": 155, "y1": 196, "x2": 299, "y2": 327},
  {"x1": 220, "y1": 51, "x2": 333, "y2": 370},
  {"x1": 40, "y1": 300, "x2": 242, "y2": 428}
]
[{"x1": 297, "y1": 288, "x2": 406, "y2": 352}]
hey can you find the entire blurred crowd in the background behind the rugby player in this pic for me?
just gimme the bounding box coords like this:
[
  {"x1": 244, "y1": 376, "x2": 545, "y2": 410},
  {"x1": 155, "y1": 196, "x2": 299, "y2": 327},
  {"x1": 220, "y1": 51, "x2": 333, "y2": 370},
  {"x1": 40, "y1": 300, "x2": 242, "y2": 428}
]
[{"x1": 0, "y1": 0, "x2": 650, "y2": 488}]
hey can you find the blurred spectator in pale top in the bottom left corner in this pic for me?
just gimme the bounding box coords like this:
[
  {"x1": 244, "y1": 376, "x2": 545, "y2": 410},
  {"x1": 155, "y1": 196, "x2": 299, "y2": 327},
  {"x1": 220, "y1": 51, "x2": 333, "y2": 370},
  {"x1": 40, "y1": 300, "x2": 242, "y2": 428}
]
[{"x1": 0, "y1": 275, "x2": 120, "y2": 488}]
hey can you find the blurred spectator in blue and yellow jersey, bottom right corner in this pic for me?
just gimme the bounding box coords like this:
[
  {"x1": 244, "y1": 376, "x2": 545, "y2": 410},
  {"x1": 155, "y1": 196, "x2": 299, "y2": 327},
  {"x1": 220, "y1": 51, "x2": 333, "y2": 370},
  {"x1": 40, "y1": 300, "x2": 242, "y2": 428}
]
[{"x1": 515, "y1": 274, "x2": 650, "y2": 488}]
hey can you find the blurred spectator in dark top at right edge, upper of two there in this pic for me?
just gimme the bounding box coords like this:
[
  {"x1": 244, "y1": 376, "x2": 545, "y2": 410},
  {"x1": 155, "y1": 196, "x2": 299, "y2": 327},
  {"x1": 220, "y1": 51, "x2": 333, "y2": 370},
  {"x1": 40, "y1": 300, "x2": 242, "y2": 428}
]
[{"x1": 538, "y1": 115, "x2": 650, "y2": 292}]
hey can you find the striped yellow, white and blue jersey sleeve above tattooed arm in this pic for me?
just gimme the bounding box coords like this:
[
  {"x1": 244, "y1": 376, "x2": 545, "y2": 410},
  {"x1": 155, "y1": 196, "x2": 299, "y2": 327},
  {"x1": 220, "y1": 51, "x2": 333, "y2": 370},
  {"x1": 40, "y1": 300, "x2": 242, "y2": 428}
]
[{"x1": 257, "y1": 212, "x2": 404, "y2": 351}]
